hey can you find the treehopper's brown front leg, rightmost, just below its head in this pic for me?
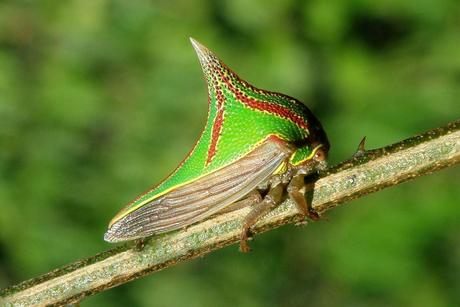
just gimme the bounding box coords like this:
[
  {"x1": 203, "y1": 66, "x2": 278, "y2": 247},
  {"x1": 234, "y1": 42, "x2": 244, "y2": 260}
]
[{"x1": 287, "y1": 173, "x2": 319, "y2": 221}]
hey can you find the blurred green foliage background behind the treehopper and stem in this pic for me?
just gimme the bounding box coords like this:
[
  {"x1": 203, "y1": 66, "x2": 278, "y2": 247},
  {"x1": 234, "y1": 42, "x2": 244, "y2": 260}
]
[{"x1": 0, "y1": 0, "x2": 460, "y2": 307}]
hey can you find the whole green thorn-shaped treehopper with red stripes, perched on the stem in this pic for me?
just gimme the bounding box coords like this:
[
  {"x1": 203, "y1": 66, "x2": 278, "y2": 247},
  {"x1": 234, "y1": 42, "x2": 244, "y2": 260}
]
[{"x1": 104, "y1": 39, "x2": 329, "y2": 251}]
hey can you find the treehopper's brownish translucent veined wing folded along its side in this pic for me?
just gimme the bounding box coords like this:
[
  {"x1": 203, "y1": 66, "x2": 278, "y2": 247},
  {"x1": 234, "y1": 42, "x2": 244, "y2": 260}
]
[{"x1": 104, "y1": 139, "x2": 292, "y2": 242}]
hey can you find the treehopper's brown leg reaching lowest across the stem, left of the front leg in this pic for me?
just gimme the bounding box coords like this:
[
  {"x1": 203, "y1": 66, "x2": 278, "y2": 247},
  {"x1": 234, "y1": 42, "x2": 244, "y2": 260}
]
[{"x1": 240, "y1": 183, "x2": 284, "y2": 253}]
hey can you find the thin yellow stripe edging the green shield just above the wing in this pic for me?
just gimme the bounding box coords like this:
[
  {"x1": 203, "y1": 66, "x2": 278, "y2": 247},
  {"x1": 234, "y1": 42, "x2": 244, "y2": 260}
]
[{"x1": 109, "y1": 133, "x2": 290, "y2": 228}]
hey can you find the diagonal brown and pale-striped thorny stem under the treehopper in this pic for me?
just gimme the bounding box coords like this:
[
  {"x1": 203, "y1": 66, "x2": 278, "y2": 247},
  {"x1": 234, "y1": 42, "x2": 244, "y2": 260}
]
[{"x1": 0, "y1": 121, "x2": 460, "y2": 306}]
